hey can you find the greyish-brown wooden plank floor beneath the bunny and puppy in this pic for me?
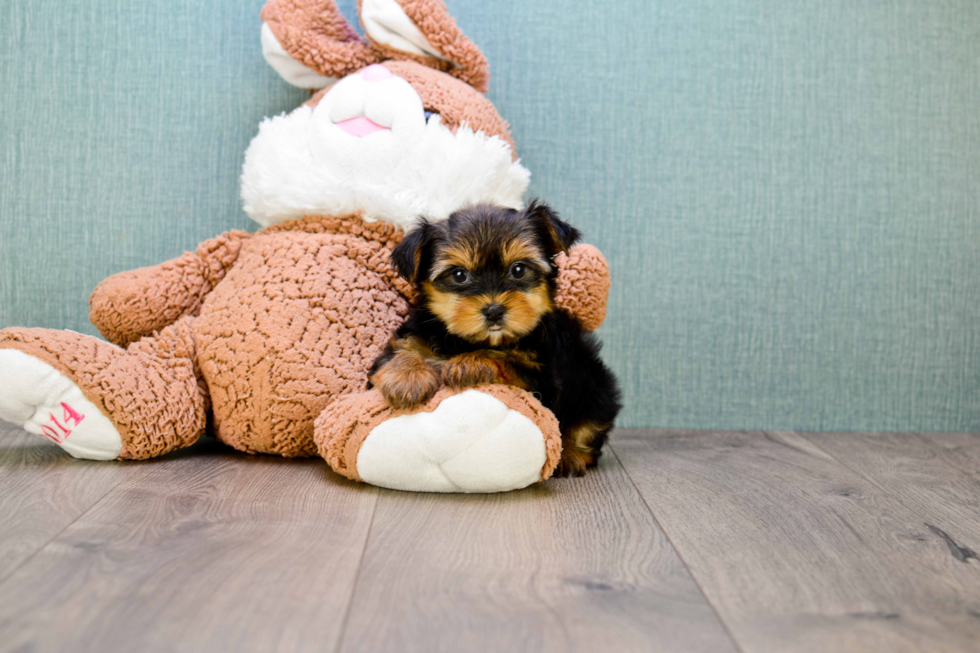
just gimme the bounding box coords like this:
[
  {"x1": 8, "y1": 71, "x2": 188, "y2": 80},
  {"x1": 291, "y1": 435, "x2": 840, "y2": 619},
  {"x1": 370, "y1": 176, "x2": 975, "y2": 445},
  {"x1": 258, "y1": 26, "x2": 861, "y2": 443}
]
[{"x1": 0, "y1": 425, "x2": 980, "y2": 653}]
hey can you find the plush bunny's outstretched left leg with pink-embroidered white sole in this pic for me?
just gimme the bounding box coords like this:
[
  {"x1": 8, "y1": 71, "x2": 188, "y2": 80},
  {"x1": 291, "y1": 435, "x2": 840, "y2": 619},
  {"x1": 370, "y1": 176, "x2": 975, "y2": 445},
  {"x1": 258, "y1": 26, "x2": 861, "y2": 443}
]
[{"x1": 0, "y1": 317, "x2": 209, "y2": 460}]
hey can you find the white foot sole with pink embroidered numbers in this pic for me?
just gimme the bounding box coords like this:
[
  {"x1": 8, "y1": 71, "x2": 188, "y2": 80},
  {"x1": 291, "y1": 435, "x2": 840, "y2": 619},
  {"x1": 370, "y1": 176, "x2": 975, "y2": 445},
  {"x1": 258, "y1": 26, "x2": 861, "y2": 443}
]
[{"x1": 0, "y1": 349, "x2": 122, "y2": 460}]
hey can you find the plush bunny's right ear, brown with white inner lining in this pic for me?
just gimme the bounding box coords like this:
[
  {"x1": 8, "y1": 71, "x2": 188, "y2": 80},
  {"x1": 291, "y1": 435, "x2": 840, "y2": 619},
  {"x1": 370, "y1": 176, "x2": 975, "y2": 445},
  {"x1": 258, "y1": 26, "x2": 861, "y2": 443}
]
[{"x1": 357, "y1": 0, "x2": 490, "y2": 93}]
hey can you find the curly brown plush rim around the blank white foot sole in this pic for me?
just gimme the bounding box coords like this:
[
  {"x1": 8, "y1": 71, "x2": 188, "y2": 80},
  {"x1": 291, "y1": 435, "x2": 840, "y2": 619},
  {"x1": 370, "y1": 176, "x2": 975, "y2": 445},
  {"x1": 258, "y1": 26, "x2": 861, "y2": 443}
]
[{"x1": 313, "y1": 385, "x2": 561, "y2": 481}]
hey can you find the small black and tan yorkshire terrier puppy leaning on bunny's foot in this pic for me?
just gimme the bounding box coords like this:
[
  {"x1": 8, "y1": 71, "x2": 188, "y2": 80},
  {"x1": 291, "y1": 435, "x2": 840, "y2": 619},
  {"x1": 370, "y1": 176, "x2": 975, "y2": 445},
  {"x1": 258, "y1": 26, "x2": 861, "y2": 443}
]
[{"x1": 368, "y1": 202, "x2": 620, "y2": 476}]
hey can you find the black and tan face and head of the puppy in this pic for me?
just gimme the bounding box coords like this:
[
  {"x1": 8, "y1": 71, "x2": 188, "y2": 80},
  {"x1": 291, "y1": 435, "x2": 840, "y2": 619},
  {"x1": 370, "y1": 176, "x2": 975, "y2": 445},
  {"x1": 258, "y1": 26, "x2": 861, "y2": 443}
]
[{"x1": 392, "y1": 202, "x2": 578, "y2": 347}]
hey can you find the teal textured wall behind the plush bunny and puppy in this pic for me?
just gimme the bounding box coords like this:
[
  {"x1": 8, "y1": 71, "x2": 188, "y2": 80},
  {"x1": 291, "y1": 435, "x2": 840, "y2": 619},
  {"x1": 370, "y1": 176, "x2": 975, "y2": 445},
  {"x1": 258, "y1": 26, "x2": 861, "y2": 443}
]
[{"x1": 0, "y1": 0, "x2": 980, "y2": 431}]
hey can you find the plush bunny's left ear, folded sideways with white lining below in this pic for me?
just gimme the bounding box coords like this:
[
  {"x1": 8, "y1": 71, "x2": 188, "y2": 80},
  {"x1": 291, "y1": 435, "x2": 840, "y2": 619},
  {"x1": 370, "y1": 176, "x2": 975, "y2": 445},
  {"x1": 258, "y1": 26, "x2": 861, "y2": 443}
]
[{"x1": 262, "y1": 0, "x2": 386, "y2": 89}]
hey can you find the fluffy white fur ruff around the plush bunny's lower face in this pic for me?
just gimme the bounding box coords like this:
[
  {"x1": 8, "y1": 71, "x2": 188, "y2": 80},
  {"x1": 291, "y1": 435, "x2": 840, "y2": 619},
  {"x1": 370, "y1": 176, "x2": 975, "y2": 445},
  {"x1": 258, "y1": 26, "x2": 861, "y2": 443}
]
[{"x1": 241, "y1": 106, "x2": 530, "y2": 230}]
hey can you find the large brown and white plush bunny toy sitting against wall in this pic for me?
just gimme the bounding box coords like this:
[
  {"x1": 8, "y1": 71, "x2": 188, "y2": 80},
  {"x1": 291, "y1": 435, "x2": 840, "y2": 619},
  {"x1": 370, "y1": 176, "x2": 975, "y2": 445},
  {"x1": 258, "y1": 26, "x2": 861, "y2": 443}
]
[{"x1": 0, "y1": 0, "x2": 609, "y2": 492}]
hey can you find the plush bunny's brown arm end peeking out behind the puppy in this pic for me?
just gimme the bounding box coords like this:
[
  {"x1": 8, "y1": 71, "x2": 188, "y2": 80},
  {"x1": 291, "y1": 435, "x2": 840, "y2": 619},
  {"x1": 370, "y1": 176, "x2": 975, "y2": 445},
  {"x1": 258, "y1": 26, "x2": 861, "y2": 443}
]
[{"x1": 555, "y1": 245, "x2": 609, "y2": 331}]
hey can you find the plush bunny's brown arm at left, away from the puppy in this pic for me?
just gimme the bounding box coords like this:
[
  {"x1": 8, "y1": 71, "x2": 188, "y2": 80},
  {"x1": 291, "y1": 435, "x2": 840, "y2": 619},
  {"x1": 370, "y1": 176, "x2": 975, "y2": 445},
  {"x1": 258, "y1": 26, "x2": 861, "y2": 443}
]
[{"x1": 89, "y1": 231, "x2": 249, "y2": 347}]
